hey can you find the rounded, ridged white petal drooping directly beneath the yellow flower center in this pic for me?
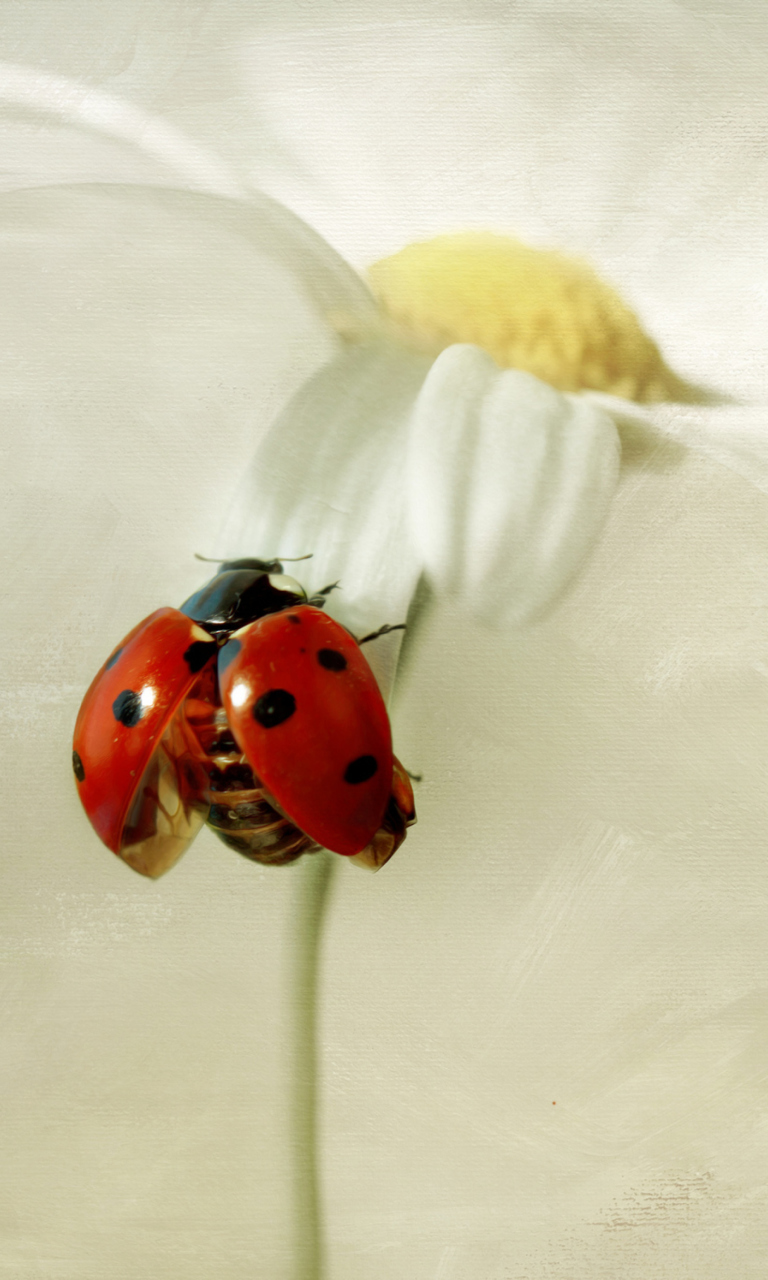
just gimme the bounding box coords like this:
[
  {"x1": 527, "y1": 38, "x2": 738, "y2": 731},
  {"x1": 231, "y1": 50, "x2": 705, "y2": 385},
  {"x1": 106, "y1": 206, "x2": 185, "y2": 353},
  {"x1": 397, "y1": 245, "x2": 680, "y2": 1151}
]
[{"x1": 408, "y1": 346, "x2": 620, "y2": 625}]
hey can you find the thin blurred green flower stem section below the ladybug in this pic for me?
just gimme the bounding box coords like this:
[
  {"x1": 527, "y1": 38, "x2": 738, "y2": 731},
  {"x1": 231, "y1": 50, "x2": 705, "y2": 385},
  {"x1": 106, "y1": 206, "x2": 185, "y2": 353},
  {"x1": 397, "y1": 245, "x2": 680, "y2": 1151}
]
[{"x1": 287, "y1": 850, "x2": 335, "y2": 1280}]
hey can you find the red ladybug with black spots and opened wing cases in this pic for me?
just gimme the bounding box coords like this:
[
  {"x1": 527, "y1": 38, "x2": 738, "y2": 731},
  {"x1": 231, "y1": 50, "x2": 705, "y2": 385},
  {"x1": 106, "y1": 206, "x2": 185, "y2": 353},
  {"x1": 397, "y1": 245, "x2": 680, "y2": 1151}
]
[{"x1": 72, "y1": 559, "x2": 416, "y2": 878}]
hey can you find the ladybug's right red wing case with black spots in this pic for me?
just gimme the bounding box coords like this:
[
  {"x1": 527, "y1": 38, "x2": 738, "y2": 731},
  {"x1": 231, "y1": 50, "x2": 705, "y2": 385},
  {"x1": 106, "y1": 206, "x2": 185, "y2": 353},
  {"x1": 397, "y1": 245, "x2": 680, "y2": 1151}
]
[{"x1": 219, "y1": 604, "x2": 393, "y2": 856}]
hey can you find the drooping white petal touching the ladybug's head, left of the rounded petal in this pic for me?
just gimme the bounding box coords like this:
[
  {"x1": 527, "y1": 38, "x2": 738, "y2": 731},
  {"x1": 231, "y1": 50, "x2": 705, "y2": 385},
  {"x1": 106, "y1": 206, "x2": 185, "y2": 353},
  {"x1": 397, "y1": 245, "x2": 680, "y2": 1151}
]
[{"x1": 220, "y1": 342, "x2": 429, "y2": 691}]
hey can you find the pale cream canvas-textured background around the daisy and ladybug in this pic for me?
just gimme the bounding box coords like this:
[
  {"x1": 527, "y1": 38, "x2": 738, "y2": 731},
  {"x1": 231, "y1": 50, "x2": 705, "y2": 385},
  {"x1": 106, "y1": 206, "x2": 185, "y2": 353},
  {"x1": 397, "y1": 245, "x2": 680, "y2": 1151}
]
[{"x1": 0, "y1": 0, "x2": 768, "y2": 1280}]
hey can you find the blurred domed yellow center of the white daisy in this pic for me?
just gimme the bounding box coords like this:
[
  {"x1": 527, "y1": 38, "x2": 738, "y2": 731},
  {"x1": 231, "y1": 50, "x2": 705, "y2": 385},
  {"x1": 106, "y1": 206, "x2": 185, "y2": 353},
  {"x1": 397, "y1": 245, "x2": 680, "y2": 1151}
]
[{"x1": 369, "y1": 232, "x2": 686, "y2": 402}]
